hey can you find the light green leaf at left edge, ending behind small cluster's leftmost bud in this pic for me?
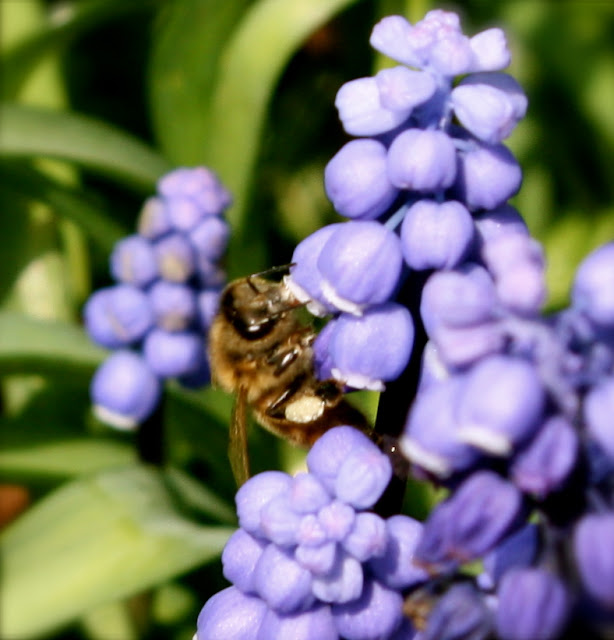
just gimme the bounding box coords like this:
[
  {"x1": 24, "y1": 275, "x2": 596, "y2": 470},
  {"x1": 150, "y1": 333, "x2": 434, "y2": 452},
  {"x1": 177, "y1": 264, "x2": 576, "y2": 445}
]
[{"x1": 0, "y1": 311, "x2": 106, "y2": 379}]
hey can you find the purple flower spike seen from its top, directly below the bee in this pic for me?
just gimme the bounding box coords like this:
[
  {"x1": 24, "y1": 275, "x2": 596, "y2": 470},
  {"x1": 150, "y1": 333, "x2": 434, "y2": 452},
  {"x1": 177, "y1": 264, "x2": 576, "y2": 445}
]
[{"x1": 196, "y1": 427, "x2": 427, "y2": 640}]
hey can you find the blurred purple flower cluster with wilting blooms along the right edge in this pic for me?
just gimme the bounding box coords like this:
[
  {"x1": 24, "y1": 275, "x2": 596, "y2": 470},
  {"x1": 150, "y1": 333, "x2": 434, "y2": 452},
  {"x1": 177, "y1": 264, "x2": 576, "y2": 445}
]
[{"x1": 400, "y1": 239, "x2": 614, "y2": 640}]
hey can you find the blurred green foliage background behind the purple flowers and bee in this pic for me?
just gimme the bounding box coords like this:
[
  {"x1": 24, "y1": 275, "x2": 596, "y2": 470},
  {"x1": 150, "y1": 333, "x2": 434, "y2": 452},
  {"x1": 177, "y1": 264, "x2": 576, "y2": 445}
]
[{"x1": 0, "y1": 0, "x2": 614, "y2": 640}]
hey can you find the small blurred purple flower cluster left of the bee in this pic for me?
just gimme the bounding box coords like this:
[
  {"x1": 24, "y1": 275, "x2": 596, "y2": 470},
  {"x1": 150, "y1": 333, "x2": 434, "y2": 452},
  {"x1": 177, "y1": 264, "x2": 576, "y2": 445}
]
[{"x1": 84, "y1": 167, "x2": 231, "y2": 429}]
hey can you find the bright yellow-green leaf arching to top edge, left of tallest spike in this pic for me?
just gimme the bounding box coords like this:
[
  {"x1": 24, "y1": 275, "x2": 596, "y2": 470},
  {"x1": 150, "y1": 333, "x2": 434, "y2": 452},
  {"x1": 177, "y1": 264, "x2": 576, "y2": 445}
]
[{"x1": 194, "y1": 0, "x2": 356, "y2": 229}]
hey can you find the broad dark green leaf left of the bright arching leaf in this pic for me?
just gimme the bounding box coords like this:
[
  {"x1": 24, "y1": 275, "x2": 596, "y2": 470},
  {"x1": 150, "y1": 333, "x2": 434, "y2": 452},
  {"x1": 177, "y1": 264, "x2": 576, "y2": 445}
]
[{"x1": 149, "y1": 0, "x2": 250, "y2": 165}]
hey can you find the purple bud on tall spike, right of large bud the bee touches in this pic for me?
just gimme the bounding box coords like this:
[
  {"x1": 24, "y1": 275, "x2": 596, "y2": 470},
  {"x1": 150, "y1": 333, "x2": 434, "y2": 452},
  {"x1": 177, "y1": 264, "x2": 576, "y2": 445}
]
[{"x1": 401, "y1": 200, "x2": 474, "y2": 270}]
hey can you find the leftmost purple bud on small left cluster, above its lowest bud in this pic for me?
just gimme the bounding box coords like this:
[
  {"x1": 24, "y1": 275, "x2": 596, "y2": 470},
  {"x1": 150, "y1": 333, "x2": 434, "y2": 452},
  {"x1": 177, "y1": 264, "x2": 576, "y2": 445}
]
[{"x1": 83, "y1": 284, "x2": 154, "y2": 349}]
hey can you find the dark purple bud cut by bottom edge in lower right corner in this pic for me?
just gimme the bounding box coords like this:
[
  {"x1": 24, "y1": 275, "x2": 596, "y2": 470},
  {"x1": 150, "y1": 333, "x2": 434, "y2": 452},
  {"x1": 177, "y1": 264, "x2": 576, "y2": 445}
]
[{"x1": 496, "y1": 568, "x2": 570, "y2": 640}]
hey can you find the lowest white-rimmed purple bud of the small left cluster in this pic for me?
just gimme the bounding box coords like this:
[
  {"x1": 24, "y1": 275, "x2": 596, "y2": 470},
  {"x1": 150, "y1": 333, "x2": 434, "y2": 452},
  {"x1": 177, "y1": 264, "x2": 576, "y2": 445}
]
[{"x1": 90, "y1": 350, "x2": 162, "y2": 429}]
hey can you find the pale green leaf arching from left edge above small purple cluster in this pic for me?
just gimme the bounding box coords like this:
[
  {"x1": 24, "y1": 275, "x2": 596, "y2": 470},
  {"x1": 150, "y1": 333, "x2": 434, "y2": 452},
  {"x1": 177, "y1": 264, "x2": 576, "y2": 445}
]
[{"x1": 0, "y1": 104, "x2": 171, "y2": 191}]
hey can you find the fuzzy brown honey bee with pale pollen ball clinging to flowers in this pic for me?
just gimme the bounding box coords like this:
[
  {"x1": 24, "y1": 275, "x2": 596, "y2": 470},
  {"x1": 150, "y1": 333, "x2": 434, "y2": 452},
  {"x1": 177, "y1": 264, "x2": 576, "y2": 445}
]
[{"x1": 209, "y1": 269, "x2": 367, "y2": 486}]
